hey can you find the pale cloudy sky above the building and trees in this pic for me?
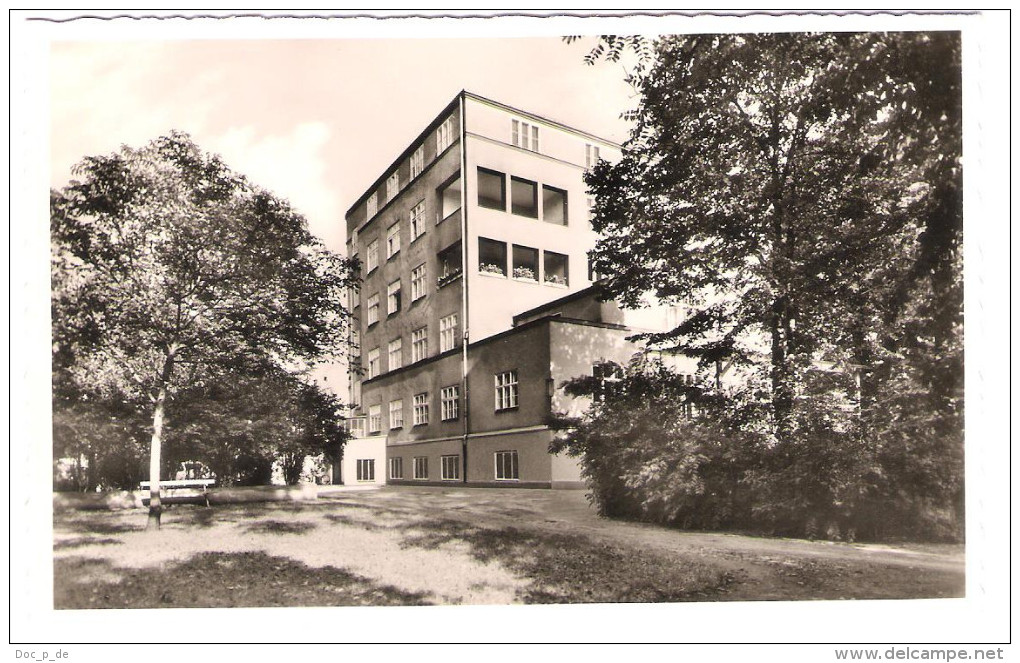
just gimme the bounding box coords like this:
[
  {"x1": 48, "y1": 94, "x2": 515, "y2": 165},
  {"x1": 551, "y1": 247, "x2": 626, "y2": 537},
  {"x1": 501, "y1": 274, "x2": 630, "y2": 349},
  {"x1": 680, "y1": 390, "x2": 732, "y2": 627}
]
[{"x1": 49, "y1": 37, "x2": 635, "y2": 251}]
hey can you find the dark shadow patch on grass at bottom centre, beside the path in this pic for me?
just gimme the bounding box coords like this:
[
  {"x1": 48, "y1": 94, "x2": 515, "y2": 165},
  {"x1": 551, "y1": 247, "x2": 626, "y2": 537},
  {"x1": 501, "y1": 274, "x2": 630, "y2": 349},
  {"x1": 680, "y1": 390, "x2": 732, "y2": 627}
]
[{"x1": 402, "y1": 520, "x2": 734, "y2": 603}]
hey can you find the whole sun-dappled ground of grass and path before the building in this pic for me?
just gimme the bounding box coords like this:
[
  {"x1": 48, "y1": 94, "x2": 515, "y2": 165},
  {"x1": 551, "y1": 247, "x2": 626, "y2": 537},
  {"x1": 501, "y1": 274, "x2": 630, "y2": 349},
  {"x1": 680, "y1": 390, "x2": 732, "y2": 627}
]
[{"x1": 54, "y1": 488, "x2": 963, "y2": 609}]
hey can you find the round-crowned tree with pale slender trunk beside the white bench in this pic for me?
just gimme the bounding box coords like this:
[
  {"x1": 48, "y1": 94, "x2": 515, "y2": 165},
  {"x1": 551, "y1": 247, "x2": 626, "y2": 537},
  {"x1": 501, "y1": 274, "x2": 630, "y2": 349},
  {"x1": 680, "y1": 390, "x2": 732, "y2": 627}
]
[{"x1": 51, "y1": 133, "x2": 363, "y2": 527}]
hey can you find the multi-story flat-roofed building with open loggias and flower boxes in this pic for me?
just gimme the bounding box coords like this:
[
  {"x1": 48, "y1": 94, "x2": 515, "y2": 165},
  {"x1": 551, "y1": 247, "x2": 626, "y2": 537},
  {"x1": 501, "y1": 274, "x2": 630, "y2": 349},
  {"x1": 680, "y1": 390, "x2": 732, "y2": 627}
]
[{"x1": 344, "y1": 92, "x2": 693, "y2": 487}]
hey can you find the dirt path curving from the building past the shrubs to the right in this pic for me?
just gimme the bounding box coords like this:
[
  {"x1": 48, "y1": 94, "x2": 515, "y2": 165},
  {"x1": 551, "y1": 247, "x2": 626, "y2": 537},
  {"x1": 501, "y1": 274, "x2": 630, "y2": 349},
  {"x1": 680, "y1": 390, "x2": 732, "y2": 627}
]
[{"x1": 320, "y1": 487, "x2": 965, "y2": 600}]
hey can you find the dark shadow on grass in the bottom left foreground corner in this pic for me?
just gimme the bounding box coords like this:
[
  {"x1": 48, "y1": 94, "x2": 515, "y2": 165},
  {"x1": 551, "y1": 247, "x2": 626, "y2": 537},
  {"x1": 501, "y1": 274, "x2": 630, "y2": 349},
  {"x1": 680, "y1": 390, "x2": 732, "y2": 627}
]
[{"x1": 53, "y1": 552, "x2": 430, "y2": 609}]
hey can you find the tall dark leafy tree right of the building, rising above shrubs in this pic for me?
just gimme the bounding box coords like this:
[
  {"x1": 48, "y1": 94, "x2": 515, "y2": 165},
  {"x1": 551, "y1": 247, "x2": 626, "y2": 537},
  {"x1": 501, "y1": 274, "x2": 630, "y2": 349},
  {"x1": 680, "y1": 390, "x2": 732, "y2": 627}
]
[{"x1": 575, "y1": 33, "x2": 963, "y2": 538}]
